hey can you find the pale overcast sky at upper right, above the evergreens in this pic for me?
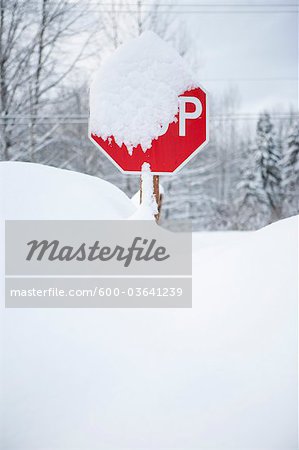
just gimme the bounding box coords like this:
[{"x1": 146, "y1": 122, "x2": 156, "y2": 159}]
[{"x1": 184, "y1": 0, "x2": 298, "y2": 113}]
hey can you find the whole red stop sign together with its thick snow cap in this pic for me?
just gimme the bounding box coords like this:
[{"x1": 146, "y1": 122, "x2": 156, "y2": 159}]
[{"x1": 89, "y1": 32, "x2": 208, "y2": 174}]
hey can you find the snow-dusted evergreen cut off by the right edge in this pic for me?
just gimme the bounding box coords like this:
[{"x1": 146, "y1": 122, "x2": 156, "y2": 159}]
[{"x1": 281, "y1": 122, "x2": 299, "y2": 216}]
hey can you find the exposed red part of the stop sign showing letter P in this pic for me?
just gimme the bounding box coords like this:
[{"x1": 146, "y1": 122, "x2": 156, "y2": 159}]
[{"x1": 89, "y1": 88, "x2": 208, "y2": 174}]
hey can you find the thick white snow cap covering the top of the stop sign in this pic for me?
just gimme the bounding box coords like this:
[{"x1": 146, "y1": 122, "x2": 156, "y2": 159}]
[{"x1": 90, "y1": 31, "x2": 198, "y2": 153}]
